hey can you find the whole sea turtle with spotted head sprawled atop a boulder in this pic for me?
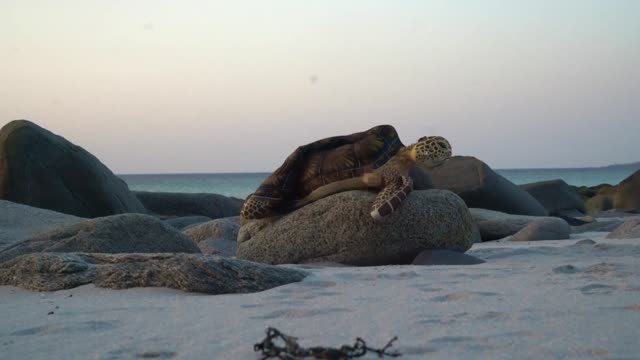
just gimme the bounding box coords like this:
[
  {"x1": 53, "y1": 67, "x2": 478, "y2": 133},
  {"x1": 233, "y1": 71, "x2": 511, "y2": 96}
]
[{"x1": 240, "y1": 125, "x2": 451, "y2": 222}]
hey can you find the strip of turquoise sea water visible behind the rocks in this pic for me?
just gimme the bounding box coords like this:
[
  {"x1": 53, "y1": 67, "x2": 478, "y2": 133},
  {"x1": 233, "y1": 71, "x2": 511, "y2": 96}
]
[{"x1": 119, "y1": 168, "x2": 634, "y2": 199}]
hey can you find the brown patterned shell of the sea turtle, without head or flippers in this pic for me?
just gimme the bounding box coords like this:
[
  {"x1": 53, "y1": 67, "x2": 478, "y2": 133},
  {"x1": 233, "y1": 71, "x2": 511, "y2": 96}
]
[{"x1": 250, "y1": 125, "x2": 404, "y2": 208}]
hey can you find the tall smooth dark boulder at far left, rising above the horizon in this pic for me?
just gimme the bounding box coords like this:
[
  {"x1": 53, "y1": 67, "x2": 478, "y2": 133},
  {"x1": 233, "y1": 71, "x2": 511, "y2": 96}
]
[{"x1": 0, "y1": 120, "x2": 146, "y2": 218}]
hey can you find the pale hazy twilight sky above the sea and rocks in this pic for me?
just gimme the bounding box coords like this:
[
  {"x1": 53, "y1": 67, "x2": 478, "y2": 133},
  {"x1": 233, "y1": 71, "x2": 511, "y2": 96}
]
[{"x1": 0, "y1": 0, "x2": 640, "y2": 174}]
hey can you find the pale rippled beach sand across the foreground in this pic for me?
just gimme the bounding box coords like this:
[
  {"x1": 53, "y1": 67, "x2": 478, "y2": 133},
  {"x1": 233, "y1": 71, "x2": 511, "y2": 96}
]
[{"x1": 0, "y1": 233, "x2": 640, "y2": 360}]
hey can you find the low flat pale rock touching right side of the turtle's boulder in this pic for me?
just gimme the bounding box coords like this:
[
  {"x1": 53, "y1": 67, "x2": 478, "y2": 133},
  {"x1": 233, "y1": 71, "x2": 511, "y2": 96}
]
[{"x1": 469, "y1": 208, "x2": 544, "y2": 241}]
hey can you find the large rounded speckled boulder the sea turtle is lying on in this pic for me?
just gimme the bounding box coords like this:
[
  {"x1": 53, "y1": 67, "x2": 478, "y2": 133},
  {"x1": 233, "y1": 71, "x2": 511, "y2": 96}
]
[{"x1": 237, "y1": 190, "x2": 479, "y2": 265}]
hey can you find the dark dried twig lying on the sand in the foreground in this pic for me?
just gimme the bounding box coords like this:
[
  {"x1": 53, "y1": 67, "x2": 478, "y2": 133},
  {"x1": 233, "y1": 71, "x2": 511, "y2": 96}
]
[{"x1": 253, "y1": 327, "x2": 401, "y2": 360}]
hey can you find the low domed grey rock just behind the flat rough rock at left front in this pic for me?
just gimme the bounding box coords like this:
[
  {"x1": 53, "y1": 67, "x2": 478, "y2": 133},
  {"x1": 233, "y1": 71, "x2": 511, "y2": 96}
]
[{"x1": 0, "y1": 214, "x2": 200, "y2": 262}]
